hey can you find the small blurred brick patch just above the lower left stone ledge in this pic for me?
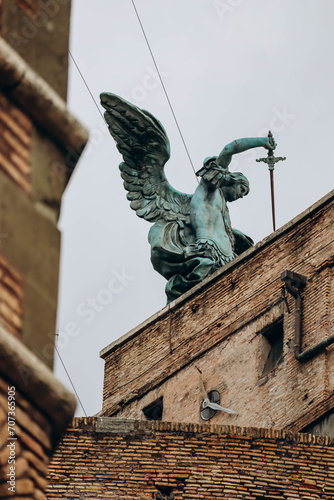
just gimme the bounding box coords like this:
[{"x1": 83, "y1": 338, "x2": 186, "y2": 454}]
[{"x1": 0, "y1": 256, "x2": 23, "y2": 337}]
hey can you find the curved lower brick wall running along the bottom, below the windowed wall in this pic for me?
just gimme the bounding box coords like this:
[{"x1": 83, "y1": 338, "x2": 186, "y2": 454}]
[{"x1": 47, "y1": 418, "x2": 334, "y2": 500}]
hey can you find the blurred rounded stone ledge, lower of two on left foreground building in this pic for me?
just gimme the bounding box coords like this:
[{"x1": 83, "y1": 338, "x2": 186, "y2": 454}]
[{"x1": 0, "y1": 326, "x2": 76, "y2": 444}]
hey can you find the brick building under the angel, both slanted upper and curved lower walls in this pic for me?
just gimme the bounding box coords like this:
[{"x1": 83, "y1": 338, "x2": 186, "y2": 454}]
[{"x1": 47, "y1": 191, "x2": 334, "y2": 500}]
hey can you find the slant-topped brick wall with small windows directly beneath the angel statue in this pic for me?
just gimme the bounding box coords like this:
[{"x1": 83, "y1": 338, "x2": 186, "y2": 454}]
[{"x1": 102, "y1": 192, "x2": 334, "y2": 430}]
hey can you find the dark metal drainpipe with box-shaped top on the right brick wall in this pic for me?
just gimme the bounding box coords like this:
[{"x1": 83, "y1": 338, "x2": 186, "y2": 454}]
[{"x1": 281, "y1": 271, "x2": 334, "y2": 363}]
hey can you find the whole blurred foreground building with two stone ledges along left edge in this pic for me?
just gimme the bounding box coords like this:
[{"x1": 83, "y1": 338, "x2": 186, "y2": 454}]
[{"x1": 0, "y1": 0, "x2": 87, "y2": 500}]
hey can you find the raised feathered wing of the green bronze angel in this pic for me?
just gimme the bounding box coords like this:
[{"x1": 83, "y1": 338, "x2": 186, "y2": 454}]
[{"x1": 100, "y1": 93, "x2": 191, "y2": 223}]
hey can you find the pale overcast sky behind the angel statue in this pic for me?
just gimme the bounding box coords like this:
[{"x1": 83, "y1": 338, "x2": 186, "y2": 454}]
[{"x1": 56, "y1": 0, "x2": 334, "y2": 415}]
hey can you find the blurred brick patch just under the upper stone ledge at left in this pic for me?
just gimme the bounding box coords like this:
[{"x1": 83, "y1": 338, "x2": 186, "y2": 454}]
[{"x1": 0, "y1": 93, "x2": 32, "y2": 195}]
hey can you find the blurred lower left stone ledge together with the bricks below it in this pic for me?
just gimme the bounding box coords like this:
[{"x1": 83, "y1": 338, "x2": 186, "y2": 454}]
[{"x1": 0, "y1": 326, "x2": 75, "y2": 500}]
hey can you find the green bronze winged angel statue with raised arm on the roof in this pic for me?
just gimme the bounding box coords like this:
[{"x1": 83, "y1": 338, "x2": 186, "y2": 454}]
[{"x1": 101, "y1": 93, "x2": 276, "y2": 303}]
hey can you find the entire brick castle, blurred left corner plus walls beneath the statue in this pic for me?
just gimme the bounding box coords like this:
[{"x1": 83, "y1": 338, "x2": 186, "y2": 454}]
[{"x1": 0, "y1": 0, "x2": 334, "y2": 500}]
